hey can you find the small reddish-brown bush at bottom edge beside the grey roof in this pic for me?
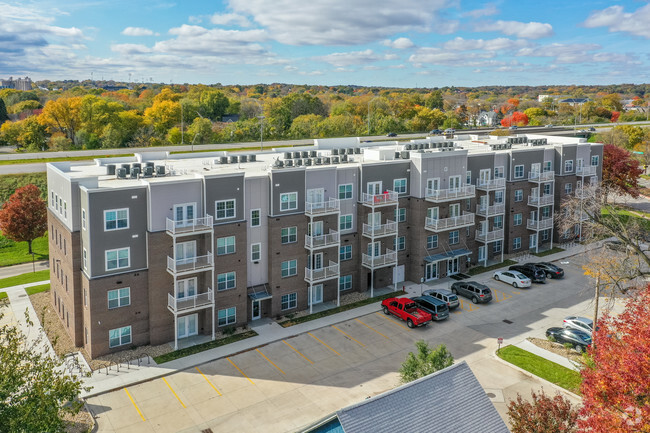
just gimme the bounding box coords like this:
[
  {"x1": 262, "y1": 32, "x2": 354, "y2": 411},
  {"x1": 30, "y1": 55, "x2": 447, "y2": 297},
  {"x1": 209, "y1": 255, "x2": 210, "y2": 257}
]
[{"x1": 508, "y1": 391, "x2": 578, "y2": 433}]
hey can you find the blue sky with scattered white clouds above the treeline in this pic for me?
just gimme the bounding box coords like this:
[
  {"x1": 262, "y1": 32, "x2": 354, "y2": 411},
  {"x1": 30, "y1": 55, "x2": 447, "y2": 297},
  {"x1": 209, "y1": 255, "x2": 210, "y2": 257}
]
[{"x1": 0, "y1": 0, "x2": 650, "y2": 87}]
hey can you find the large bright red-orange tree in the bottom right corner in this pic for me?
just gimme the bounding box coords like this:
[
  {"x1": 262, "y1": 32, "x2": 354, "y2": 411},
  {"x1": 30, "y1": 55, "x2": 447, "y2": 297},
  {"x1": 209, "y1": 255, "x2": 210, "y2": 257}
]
[{"x1": 578, "y1": 286, "x2": 650, "y2": 433}]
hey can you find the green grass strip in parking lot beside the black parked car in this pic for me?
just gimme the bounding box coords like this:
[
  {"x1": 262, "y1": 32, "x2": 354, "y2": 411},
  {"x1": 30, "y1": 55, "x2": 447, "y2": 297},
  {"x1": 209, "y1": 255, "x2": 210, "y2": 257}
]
[{"x1": 497, "y1": 346, "x2": 582, "y2": 394}]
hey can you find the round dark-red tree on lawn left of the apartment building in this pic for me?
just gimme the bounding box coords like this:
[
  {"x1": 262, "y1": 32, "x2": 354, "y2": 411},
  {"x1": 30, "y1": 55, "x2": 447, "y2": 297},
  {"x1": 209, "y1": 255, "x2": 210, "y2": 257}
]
[{"x1": 0, "y1": 184, "x2": 47, "y2": 254}]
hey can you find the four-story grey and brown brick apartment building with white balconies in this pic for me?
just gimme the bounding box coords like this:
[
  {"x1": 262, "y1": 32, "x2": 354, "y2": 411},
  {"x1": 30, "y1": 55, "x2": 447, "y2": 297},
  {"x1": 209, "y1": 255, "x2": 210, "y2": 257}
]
[{"x1": 47, "y1": 135, "x2": 602, "y2": 357}]
